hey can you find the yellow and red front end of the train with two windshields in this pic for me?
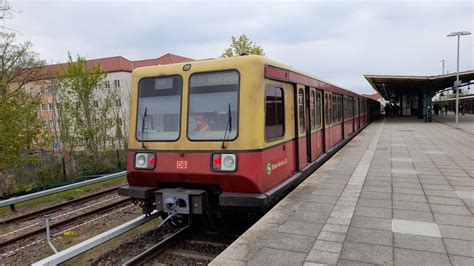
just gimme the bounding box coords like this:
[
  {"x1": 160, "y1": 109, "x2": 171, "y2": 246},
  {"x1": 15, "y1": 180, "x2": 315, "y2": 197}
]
[{"x1": 119, "y1": 57, "x2": 265, "y2": 221}]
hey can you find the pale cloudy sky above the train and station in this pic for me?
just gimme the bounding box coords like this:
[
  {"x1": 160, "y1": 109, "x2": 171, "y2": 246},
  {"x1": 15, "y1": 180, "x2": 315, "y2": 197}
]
[{"x1": 3, "y1": 0, "x2": 474, "y2": 94}]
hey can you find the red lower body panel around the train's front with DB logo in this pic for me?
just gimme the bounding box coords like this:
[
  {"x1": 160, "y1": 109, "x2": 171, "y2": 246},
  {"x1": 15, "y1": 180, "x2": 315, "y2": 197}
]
[{"x1": 127, "y1": 142, "x2": 295, "y2": 193}]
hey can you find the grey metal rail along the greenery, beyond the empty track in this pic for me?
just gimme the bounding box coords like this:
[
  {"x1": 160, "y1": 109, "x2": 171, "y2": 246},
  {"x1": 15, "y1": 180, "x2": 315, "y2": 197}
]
[{"x1": 0, "y1": 171, "x2": 126, "y2": 210}]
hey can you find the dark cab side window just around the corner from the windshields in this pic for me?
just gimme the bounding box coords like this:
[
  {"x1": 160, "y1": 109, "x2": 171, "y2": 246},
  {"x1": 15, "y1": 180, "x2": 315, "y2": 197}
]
[{"x1": 265, "y1": 86, "x2": 285, "y2": 140}]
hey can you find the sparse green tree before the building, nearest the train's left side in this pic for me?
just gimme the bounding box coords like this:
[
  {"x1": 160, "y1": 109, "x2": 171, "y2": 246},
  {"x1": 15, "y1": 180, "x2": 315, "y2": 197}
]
[{"x1": 58, "y1": 53, "x2": 115, "y2": 172}]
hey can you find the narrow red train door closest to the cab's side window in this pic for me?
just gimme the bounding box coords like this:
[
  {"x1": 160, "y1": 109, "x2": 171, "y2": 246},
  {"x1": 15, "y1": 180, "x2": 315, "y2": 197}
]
[{"x1": 297, "y1": 85, "x2": 308, "y2": 169}]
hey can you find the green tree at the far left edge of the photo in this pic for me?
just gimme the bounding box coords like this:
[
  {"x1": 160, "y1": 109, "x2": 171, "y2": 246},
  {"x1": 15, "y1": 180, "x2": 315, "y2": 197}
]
[{"x1": 0, "y1": 32, "x2": 44, "y2": 172}]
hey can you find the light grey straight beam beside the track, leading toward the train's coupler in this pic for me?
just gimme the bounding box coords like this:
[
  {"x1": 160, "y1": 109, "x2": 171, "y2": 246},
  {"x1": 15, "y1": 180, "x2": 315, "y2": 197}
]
[{"x1": 32, "y1": 211, "x2": 158, "y2": 266}]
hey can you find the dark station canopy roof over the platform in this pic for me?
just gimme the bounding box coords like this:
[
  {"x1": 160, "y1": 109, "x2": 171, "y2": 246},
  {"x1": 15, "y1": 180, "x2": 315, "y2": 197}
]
[{"x1": 364, "y1": 70, "x2": 474, "y2": 100}]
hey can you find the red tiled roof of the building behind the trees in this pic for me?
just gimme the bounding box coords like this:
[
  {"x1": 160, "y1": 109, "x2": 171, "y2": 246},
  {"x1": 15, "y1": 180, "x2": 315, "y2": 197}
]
[{"x1": 32, "y1": 53, "x2": 194, "y2": 79}]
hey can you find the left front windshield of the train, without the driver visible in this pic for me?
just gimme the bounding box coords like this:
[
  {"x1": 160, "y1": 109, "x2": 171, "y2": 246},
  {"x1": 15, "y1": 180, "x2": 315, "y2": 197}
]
[{"x1": 136, "y1": 76, "x2": 183, "y2": 141}]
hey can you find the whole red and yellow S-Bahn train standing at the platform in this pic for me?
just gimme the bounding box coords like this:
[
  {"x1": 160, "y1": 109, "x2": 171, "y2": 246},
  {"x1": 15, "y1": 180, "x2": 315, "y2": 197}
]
[{"x1": 119, "y1": 55, "x2": 380, "y2": 223}]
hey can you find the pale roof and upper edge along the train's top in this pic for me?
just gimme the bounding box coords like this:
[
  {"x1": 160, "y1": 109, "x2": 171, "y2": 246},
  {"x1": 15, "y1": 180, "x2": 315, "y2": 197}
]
[{"x1": 134, "y1": 55, "x2": 370, "y2": 99}]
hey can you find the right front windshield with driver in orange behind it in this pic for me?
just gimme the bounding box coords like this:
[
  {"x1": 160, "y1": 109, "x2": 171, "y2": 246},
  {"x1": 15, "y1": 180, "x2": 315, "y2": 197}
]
[{"x1": 188, "y1": 71, "x2": 239, "y2": 140}]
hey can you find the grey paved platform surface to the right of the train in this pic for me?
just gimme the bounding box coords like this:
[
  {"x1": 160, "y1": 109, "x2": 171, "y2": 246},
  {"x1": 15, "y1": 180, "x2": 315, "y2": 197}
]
[{"x1": 211, "y1": 118, "x2": 474, "y2": 266}]
